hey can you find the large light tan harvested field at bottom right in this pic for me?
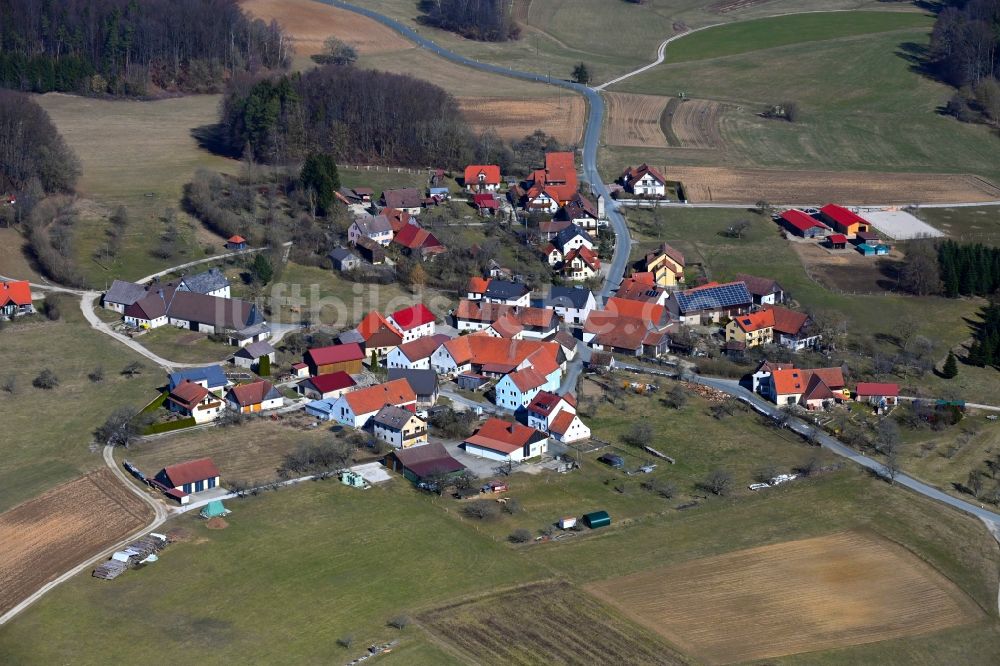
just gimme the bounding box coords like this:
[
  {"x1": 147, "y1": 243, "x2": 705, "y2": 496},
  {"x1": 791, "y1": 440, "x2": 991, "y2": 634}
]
[{"x1": 589, "y1": 532, "x2": 983, "y2": 664}]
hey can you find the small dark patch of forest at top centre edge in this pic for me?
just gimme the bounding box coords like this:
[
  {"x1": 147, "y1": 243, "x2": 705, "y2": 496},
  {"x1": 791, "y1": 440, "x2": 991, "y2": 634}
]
[{"x1": 418, "y1": 0, "x2": 521, "y2": 42}]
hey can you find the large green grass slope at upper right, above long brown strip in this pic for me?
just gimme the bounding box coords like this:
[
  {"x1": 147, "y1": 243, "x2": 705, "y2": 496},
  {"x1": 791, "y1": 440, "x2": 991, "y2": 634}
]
[{"x1": 604, "y1": 12, "x2": 1000, "y2": 182}]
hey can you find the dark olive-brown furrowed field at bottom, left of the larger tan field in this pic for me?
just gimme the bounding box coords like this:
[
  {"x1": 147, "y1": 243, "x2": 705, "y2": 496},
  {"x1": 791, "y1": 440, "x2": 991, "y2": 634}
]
[{"x1": 418, "y1": 582, "x2": 684, "y2": 666}]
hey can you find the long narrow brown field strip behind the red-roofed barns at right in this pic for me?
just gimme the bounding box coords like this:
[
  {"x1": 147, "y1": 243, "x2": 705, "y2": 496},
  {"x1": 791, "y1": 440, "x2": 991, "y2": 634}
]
[{"x1": 662, "y1": 166, "x2": 1000, "y2": 205}]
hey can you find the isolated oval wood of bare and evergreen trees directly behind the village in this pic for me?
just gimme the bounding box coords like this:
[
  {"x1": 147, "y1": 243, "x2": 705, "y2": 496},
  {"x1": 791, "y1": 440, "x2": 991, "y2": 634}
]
[{"x1": 220, "y1": 65, "x2": 474, "y2": 167}]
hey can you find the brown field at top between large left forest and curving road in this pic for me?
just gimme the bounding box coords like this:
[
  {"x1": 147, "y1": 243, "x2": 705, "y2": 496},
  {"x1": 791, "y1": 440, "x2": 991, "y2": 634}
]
[{"x1": 240, "y1": 0, "x2": 414, "y2": 56}]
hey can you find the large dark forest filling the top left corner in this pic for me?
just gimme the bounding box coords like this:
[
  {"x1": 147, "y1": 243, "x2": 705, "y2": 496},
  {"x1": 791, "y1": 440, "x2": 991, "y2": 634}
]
[{"x1": 0, "y1": 0, "x2": 292, "y2": 96}]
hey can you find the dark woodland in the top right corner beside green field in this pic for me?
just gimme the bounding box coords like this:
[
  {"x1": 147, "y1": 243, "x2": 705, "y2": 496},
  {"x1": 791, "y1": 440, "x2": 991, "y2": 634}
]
[{"x1": 930, "y1": 0, "x2": 1000, "y2": 124}]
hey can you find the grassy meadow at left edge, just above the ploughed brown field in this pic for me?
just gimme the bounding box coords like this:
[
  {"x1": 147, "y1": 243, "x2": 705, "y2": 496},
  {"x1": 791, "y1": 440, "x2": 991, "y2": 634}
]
[{"x1": 0, "y1": 298, "x2": 160, "y2": 511}]
